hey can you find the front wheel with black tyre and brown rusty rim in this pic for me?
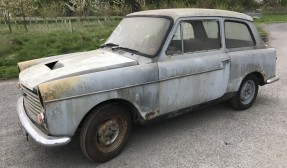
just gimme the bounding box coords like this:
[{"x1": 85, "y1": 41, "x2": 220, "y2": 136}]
[{"x1": 80, "y1": 103, "x2": 132, "y2": 163}]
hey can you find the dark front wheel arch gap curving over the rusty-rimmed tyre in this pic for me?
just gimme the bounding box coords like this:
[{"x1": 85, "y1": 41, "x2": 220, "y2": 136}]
[{"x1": 77, "y1": 99, "x2": 141, "y2": 129}]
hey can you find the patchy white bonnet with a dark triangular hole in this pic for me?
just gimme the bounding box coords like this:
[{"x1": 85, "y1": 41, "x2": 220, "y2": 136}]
[{"x1": 19, "y1": 50, "x2": 138, "y2": 89}]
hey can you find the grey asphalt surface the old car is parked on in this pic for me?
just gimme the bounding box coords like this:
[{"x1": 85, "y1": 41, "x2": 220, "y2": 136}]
[{"x1": 0, "y1": 24, "x2": 287, "y2": 168}]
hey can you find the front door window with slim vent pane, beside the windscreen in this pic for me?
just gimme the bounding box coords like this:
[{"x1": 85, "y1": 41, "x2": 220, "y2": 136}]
[{"x1": 166, "y1": 20, "x2": 221, "y2": 55}]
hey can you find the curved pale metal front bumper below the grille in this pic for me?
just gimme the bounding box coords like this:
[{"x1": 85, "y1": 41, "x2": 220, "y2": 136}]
[{"x1": 17, "y1": 97, "x2": 71, "y2": 146}]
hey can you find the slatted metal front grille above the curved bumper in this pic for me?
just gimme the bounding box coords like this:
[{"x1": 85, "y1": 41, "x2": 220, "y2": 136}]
[{"x1": 22, "y1": 86, "x2": 44, "y2": 123}]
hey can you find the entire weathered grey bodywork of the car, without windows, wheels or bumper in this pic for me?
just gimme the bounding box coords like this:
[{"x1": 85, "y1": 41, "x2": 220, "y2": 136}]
[{"x1": 18, "y1": 9, "x2": 276, "y2": 144}]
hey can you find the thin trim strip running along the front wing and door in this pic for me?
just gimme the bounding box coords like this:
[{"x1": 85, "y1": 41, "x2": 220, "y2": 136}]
[{"x1": 44, "y1": 68, "x2": 222, "y2": 103}]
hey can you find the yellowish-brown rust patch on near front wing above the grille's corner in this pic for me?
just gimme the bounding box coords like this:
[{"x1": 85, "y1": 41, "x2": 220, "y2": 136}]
[{"x1": 39, "y1": 76, "x2": 80, "y2": 102}]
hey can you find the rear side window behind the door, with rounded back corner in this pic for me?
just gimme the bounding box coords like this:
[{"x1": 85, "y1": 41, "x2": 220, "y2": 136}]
[{"x1": 224, "y1": 21, "x2": 255, "y2": 48}]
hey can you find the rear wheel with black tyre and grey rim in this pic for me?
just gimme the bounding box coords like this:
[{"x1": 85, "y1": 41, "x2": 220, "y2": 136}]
[{"x1": 231, "y1": 75, "x2": 258, "y2": 110}]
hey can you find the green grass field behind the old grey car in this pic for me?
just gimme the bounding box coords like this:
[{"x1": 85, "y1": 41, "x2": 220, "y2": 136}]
[{"x1": 0, "y1": 15, "x2": 287, "y2": 79}]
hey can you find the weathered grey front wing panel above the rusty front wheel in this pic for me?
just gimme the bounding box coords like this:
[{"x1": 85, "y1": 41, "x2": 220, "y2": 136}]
[{"x1": 39, "y1": 63, "x2": 159, "y2": 135}]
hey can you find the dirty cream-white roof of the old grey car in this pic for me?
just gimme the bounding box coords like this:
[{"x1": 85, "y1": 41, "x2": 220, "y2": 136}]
[{"x1": 127, "y1": 8, "x2": 253, "y2": 21}]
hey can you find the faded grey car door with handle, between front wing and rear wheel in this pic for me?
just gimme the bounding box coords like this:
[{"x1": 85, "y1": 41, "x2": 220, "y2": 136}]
[{"x1": 159, "y1": 51, "x2": 230, "y2": 113}]
